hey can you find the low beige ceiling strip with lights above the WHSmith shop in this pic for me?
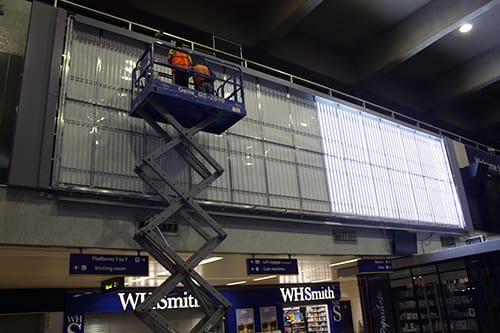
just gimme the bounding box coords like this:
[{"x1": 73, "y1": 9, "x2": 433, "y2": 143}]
[{"x1": 0, "y1": 246, "x2": 356, "y2": 289}]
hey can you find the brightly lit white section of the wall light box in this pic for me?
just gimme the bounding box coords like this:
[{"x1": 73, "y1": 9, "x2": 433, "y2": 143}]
[{"x1": 317, "y1": 99, "x2": 465, "y2": 228}]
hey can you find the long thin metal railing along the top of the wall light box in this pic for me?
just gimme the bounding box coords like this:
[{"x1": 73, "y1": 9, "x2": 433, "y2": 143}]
[{"x1": 54, "y1": 0, "x2": 500, "y2": 155}]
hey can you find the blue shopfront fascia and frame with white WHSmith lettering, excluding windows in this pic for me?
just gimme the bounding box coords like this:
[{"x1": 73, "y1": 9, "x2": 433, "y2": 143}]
[{"x1": 64, "y1": 283, "x2": 342, "y2": 333}]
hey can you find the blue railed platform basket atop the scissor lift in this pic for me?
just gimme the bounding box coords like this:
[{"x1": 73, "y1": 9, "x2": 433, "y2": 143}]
[{"x1": 129, "y1": 44, "x2": 246, "y2": 134}]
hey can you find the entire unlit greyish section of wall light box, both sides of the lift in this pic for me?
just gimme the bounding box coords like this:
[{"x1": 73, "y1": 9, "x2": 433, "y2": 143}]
[{"x1": 54, "y1": 23, "x2": 332, "y2": 213}]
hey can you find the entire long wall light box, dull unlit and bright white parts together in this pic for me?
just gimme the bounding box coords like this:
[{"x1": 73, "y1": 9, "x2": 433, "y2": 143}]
[{"x1": 48, "y1": 16, "x2": 463, "y2": 226}]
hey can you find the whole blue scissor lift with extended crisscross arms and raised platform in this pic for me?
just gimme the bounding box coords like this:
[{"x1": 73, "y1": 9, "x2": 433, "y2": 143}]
[{"x1": 129, "y1": 43, "x2": 246, "y2": 333}]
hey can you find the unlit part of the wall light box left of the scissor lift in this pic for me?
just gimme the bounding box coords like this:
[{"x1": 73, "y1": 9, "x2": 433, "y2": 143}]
[{"x1": 54, "y1": 24, "x2": 144, "y2": 192}]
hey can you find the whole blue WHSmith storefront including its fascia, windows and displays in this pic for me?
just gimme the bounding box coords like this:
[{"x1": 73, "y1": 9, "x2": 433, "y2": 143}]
[{"x1": 63, "y1": 283, "x2": 344, "y2": 333}]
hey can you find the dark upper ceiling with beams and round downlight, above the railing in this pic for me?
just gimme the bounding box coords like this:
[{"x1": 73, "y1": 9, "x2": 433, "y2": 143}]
[{"x1": 59, "y1": 0, "x2": 500, "y2": 149}]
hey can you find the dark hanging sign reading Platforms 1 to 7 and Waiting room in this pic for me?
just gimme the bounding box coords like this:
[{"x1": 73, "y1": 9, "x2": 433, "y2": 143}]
[{"x1": 69, "y1": 253, "x2": 149, "y2": 275}]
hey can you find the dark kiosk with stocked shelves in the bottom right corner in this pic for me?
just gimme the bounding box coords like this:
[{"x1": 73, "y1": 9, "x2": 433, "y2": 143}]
[{"x1": 389, "y1": 240, "x2": 500, "y2": 333}]
